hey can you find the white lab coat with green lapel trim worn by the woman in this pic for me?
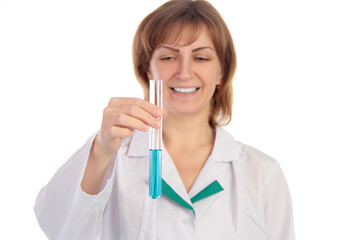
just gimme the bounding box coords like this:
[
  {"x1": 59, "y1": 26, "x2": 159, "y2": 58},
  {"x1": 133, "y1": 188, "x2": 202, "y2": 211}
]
[{"x1": 35, "y1": 127, "x2": 295, "y2": 240}]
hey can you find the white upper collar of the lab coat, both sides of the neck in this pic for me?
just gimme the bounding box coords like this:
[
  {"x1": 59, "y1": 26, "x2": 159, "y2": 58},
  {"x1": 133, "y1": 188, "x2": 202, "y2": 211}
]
[{"x1": 127, "y1": 126, "x2": 243, "y2": 162}]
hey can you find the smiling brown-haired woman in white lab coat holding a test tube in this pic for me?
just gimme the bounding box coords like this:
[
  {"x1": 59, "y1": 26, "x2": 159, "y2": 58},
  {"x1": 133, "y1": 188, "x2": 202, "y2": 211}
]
[{"x1": 35, "y1": 0, "x2": 294, "y2": 240}]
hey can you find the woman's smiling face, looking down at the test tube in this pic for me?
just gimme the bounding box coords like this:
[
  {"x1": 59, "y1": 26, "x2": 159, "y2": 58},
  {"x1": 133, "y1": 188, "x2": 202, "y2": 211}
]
[{"x1": 148, "y1": 28, "x2": 222, "y2": 116}]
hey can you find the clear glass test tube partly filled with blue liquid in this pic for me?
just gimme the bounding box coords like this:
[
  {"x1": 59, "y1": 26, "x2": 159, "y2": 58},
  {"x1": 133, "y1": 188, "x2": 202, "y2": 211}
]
[{"x1": 149, "y1": 80, "x2": 163, "y2": 199}]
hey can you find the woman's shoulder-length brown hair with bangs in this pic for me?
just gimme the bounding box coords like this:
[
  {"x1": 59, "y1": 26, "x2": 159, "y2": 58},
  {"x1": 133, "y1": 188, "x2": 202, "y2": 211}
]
[{"x1": 133, "y1": 0, "x2": 236, "y2": 127}]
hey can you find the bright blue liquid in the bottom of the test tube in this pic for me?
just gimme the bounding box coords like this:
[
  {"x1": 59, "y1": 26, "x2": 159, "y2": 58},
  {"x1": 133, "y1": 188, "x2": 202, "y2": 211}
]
[{"x1": 149, "y1": 149, "x2": 162, "y2": 198}]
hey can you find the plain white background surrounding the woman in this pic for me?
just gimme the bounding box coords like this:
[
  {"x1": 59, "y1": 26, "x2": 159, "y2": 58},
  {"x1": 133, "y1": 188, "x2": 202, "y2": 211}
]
[{"x1": 0, "y1": 0, "x2": 360, "y2": 240}]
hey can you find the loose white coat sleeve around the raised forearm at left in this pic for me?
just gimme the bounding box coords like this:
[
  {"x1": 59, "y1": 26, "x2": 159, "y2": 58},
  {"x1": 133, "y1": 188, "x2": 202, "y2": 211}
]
[{"x1": 34, "y1": 134, "x2": 116, "y2": 240}]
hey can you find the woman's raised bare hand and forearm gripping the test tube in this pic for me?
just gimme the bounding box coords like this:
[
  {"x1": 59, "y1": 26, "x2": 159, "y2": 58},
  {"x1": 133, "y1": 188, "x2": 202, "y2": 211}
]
[{"x1": 81, "y1": 98, "x2": 162, "y2": 195}]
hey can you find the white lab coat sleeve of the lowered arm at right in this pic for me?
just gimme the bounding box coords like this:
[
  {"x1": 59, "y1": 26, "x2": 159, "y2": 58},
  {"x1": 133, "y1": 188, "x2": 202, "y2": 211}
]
[{"x1": 263, "y1": 162, "x2": 295, "y2": 240}]
